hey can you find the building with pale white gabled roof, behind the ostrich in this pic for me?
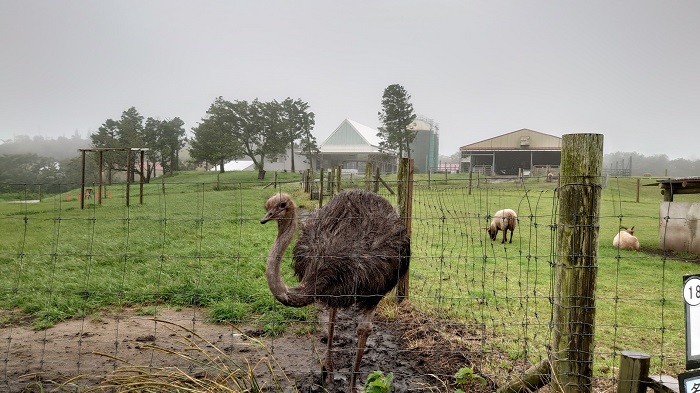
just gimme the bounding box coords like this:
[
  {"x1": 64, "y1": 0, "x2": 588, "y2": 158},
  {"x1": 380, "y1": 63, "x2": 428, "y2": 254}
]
[{"x1": 318, "y1": 119, "x2": 397, "y2": 173}]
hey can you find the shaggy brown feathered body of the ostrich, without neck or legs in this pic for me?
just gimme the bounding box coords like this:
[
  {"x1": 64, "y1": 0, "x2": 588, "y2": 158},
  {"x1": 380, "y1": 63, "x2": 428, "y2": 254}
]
[{"x1": 293, "y1": 190, "x2": 410, "y2": 309}]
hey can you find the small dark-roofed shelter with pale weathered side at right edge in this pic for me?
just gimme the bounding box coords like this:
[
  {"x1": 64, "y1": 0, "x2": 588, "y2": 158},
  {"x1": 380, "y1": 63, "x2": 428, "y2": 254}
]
[{"x1": 656, "y1": 176, "x2": 700, "y2": 254}]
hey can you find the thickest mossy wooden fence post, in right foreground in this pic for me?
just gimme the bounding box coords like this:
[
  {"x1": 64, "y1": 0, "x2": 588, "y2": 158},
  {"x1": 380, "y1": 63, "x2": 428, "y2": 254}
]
[{"x1": 549, "y1": 134, "x2": 603, "y2": 393}]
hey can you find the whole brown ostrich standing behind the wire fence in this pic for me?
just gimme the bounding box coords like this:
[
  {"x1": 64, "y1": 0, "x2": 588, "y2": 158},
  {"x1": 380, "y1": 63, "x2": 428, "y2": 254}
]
[{"x1": 260, "y1": 190, "x2": 411, "y2": 391}]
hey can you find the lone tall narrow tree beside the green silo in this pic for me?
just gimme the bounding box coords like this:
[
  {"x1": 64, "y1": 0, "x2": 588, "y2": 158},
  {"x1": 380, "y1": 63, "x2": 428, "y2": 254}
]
[{"x1": 377, "y1": 84, "x2": 417, "y2": 158}]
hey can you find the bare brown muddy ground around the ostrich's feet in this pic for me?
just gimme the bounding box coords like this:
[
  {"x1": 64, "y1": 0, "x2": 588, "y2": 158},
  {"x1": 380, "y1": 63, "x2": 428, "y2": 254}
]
[{"x1": 0, "y1": 302, "x2": 504, "y2": 392}]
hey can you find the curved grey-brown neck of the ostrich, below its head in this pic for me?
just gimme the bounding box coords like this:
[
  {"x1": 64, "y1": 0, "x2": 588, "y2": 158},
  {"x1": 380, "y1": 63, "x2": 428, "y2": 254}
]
[{"x1": 265, "y1": 214, "x2": 313, "y2": 307}]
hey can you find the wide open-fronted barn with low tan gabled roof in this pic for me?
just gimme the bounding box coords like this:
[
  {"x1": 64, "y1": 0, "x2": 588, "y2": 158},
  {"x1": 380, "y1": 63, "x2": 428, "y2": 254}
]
[{"x1": 459, "y1": 128, "x2": 561, "y2": 176}]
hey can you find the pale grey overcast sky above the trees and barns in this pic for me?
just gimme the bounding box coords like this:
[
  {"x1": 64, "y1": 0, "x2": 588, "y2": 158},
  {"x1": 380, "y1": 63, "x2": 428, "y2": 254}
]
[{"x1": 0, "y1": 0, "x2": 700, "y2": 159}]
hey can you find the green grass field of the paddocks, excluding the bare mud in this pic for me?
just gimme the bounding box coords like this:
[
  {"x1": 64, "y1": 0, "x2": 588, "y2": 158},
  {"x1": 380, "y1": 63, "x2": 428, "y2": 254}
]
[{"x1": 0, "y1": 172, "x2": 700, "y2": 375}]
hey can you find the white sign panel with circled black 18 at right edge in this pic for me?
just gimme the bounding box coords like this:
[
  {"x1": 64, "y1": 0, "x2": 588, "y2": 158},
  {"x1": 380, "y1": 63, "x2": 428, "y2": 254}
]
[{"x1": 683, "y1": 274, "x2": 700, "y2": 370}]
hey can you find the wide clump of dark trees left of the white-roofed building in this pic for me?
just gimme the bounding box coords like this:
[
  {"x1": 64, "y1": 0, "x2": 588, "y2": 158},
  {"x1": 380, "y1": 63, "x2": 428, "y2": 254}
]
[{"x1": 189, "y1": 97, "x2": 318, "y2": 179}]
